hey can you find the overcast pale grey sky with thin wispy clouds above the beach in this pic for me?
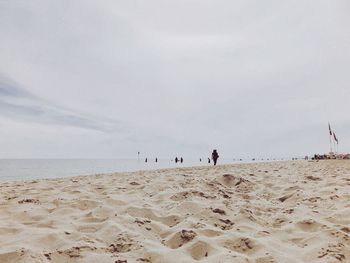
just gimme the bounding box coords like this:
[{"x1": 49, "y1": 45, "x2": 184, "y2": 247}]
[{"x1": 0, "y1": 0, "x2": 350, "y2": 158}]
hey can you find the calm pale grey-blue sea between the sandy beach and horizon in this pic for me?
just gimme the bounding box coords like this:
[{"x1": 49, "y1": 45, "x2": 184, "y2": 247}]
[{"x1": 0, "y1": 159, "x2": 282, "y2": 181}]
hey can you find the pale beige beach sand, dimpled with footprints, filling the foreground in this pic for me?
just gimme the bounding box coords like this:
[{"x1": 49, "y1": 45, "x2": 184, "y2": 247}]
[{"x1": 0, "y1": 160, "x2": 350, "y2": 263}]
